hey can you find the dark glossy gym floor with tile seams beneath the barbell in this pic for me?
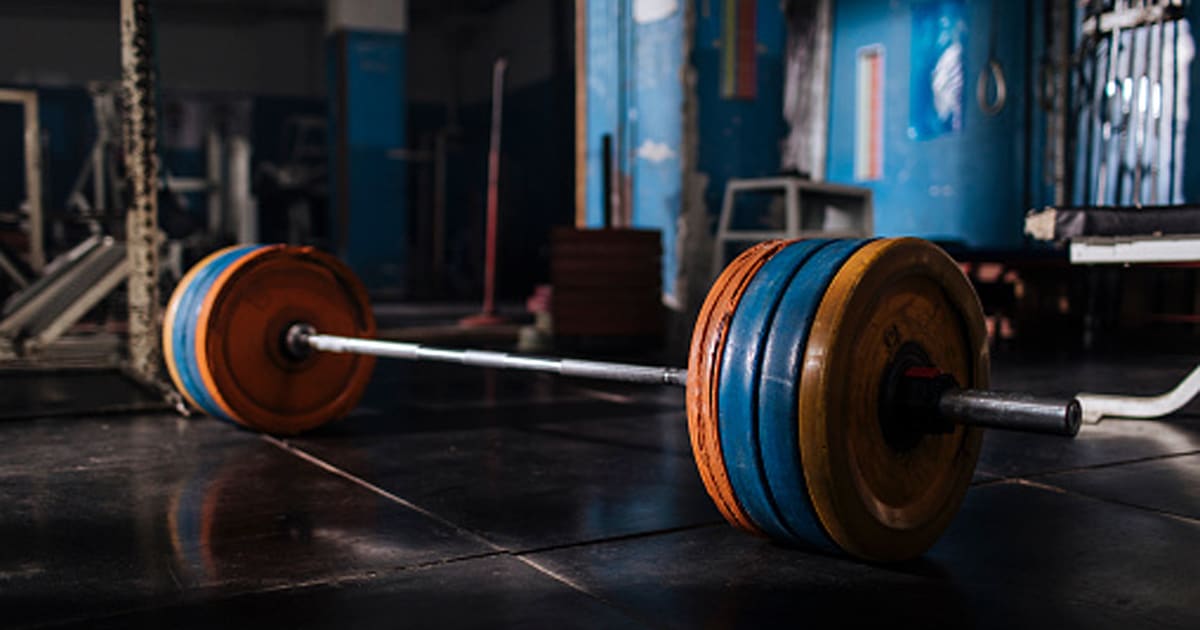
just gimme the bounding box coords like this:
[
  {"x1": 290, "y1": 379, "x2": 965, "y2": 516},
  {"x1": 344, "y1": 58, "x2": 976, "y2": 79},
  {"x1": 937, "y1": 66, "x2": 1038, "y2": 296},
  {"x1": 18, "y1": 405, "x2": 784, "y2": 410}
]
[{"x1": 0, "y1": 343, "x2": 1200, "y2": 629}]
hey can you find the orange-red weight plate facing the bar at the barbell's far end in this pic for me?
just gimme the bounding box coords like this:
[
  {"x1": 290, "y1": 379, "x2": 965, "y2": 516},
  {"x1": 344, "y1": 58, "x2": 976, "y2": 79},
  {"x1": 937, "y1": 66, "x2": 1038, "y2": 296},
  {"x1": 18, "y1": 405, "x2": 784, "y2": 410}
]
[{"x1": 196, "y1": 246, "x2": 376, "y2": 434}]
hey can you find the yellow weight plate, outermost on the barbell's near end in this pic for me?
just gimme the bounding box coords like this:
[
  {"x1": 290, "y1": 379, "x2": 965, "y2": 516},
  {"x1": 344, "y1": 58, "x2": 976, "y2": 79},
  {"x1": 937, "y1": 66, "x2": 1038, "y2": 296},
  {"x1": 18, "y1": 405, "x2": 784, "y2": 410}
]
[{"x1": 798, "y1": 239, "x2": 988, "y2": 562}]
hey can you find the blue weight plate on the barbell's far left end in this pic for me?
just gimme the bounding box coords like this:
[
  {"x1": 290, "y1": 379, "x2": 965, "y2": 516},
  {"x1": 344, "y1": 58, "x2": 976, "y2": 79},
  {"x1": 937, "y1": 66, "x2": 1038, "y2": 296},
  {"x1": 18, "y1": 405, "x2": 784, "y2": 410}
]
[{"x1": 170, "y1": 245, "x2": 260, "y2": 421}]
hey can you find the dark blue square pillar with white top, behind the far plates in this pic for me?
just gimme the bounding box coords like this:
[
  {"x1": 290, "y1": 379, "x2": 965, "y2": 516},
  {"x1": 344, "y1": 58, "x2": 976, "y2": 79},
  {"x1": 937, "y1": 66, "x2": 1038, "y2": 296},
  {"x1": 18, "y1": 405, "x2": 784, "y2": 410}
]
[{"x1": 326, "y1": 0, "x2": 409, "y2": 289}]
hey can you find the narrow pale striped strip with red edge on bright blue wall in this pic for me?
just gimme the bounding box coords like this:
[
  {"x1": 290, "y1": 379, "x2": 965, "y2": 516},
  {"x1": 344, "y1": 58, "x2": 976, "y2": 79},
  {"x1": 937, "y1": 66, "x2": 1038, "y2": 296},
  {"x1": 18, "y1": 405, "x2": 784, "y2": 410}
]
[{"x1": 854, "y1": 44, "x2": 884, "y2": 181}]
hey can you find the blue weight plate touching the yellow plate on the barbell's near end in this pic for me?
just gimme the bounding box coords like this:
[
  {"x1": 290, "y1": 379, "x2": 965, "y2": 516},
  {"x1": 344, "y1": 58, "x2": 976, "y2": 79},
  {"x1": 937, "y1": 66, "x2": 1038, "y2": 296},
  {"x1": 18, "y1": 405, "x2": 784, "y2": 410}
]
[{"x1": 755, "y1": 240, "x2": 869, "y2": 551}]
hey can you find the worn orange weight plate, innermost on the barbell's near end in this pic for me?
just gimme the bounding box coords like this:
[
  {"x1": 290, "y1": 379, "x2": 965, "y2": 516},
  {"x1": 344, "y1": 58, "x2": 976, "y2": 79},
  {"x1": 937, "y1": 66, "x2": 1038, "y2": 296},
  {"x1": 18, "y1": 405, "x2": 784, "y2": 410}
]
[{"x1": 686, "y1": 240, "x2": 785, "y2": 535}]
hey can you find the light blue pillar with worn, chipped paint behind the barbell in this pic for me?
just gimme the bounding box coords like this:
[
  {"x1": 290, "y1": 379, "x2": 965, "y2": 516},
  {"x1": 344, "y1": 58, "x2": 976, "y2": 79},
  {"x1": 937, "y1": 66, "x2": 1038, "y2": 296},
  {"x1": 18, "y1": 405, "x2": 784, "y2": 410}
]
[{"x1": 586, "y1": 0, "x2": 686, "y2": 300}]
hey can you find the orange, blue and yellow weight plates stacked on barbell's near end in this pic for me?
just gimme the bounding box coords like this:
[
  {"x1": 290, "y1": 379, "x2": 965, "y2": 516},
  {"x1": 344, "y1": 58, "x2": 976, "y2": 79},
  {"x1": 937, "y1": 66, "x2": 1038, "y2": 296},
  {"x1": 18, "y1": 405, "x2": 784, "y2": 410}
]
[{"x1": 688, "y1": 239, "x2": 988, "y2": 560}]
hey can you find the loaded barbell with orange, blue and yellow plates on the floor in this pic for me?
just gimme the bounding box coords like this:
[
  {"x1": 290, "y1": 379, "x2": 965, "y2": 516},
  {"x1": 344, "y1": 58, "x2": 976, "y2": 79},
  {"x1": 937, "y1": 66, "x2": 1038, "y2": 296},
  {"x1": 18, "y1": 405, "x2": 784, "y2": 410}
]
[{"x1": 162, "y1": 238, "x2": 1080, "y2": 562}]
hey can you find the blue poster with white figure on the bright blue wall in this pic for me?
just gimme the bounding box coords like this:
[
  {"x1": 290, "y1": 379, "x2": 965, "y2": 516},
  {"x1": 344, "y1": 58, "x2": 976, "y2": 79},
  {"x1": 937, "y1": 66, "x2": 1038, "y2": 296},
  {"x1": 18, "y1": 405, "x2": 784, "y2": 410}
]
[{"x1": 908, "y1": 0, "x2": 967, "y2": 140}]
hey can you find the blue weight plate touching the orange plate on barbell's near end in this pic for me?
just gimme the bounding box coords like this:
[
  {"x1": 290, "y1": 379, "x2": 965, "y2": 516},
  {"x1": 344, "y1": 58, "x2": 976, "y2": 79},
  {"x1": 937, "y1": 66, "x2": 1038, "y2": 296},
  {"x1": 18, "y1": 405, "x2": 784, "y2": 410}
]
[{"x1": 718, "y1": 240, "x2": 829, "y2": 541}]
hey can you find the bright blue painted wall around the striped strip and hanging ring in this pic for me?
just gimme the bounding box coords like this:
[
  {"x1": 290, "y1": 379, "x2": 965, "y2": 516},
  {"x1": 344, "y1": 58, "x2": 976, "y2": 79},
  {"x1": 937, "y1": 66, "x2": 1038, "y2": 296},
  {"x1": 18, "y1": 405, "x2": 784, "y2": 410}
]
[{"x1": 827, "y1": 0, "x2": 1030, "y2": 248}]
